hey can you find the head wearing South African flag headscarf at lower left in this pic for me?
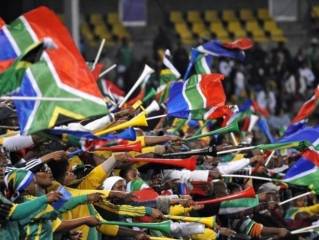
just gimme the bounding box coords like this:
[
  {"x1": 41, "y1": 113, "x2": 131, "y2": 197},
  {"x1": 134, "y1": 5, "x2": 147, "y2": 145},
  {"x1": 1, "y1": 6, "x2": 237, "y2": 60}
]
[{"x1": 4, "y1": 169, "x2": 36, "y2": 201}]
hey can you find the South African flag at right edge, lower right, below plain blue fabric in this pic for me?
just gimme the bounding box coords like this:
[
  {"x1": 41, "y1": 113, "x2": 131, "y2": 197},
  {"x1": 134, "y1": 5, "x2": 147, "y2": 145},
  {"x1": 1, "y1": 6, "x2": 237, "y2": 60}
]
[{"x1": 284, "y1": 150, "x2": 319, "y2": 192}]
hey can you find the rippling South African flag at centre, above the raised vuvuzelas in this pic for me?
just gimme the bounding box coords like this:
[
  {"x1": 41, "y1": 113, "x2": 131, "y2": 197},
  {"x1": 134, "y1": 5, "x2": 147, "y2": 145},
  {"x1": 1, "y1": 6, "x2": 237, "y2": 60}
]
[{"x1": 167, "y1": 73, "x2": 226, "y2": 120}]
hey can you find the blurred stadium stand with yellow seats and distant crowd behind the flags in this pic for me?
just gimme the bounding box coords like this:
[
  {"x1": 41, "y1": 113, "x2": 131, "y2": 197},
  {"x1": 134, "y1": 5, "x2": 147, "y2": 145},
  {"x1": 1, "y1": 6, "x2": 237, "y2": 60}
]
[{"x1": 0, "y1": 0, "x2": 319, "y2": 127}]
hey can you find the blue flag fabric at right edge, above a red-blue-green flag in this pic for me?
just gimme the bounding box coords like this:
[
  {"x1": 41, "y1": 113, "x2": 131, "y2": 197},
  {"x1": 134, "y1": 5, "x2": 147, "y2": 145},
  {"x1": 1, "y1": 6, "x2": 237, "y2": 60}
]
[{"x1": 278, "y1": 127, "x2": 319, "y2": 148}]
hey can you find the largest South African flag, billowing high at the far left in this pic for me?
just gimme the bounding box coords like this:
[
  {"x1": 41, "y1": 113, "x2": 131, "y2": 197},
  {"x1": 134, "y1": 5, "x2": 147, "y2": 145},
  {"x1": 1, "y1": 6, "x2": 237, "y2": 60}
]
[{"x1": 0, "y1": 7, "x2": 107, "y2": 134}]
